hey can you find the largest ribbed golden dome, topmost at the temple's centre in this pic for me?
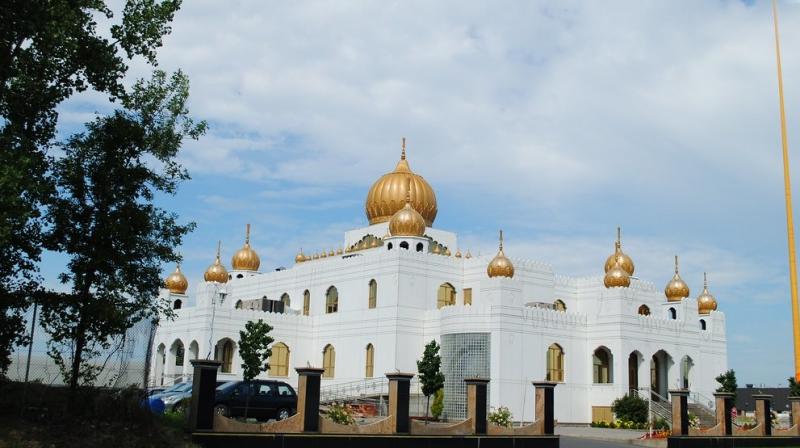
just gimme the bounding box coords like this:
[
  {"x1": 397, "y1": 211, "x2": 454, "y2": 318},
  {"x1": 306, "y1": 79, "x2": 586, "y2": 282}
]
[{"x1": 364, "y1": 138, "x2": 438, "y2": 226}]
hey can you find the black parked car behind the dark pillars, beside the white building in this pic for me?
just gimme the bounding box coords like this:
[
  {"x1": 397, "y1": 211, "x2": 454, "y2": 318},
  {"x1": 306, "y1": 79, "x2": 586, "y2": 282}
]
[{"x1": 214, "y1": 380, "x2": 297, "y2": 421}]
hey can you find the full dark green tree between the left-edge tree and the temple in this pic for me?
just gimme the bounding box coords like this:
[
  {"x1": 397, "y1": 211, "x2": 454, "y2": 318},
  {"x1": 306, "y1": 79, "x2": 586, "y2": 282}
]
[{"x1": 42, "y1": 71, "x2": 205, "y2": 389}]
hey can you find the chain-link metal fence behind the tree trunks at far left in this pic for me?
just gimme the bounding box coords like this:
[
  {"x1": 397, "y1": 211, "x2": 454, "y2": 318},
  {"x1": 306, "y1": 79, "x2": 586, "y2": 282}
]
[{"x1": 6, "y1": 309, "x2": 156, "y2": 388}]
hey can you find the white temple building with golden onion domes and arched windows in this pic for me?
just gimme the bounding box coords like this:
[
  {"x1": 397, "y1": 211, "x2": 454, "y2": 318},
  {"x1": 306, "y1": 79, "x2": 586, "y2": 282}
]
[{"x1": 151, "y1": 140, "x2": 728, "y2": 423}]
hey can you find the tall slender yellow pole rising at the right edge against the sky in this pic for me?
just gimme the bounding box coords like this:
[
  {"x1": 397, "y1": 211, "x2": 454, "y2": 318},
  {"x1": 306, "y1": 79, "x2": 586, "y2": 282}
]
[{"x1": 772, "y1": 0, "x2": 800, "y2": 381}]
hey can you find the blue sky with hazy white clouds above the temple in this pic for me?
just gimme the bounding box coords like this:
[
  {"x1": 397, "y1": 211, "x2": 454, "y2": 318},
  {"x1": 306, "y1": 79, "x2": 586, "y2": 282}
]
[{"x1": 42, "y1": 0, "x2": 800, "y2": 386}]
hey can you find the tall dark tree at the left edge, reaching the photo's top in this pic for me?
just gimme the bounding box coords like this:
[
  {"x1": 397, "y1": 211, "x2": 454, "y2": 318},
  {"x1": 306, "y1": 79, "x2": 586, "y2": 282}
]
[{"x1": 0, "y1": 0, "x2": 180, "y2": 375}]
